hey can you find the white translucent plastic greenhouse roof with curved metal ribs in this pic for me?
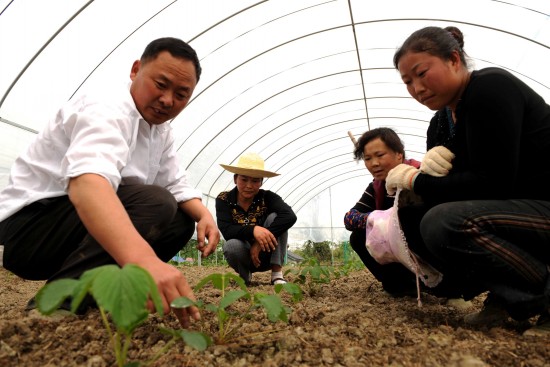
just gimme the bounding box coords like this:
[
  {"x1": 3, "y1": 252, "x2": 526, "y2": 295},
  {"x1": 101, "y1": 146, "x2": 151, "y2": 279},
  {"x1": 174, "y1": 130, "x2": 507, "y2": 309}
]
[{"x1": 0, "y1": 0, "x2": 550, "y2": 246}]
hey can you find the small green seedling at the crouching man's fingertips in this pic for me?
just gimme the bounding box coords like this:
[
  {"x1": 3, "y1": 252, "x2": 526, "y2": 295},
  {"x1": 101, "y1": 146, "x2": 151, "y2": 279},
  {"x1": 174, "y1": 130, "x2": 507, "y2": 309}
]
[{"x1": 170, "y1": 273, "x2": 301, "y2": 344}]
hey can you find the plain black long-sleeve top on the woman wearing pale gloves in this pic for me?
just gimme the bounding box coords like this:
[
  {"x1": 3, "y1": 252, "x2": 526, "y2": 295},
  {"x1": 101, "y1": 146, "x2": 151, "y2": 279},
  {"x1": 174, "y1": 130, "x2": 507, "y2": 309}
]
[{"x1": 414, "y1": 68, "x2": 550, "y2": 203}]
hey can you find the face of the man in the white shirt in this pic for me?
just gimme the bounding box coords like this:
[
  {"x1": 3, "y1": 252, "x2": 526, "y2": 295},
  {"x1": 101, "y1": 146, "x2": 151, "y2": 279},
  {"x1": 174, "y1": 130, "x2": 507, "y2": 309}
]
[{"x1": 130, "y1": 51, "x2": 197, "y2": 125}]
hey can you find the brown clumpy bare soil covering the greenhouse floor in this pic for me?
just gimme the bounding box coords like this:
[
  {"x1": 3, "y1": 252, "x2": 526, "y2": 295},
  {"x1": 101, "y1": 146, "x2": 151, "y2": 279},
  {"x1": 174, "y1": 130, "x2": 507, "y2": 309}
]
[{"x1": 0, "y1": 266, "x2": 550, "y2": 367}]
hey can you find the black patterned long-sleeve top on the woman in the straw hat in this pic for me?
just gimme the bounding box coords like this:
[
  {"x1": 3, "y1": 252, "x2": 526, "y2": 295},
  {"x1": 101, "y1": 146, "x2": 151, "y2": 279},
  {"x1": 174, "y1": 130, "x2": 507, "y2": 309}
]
[{"x1": 216, "y1": 187, "x2": 298, "y2": 243}]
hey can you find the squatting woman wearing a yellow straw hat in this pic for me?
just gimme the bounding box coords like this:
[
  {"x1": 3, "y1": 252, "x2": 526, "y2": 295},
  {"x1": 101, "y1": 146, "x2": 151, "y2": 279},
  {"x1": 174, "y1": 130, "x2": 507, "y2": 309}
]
[{"x1": 216, "y1": 153, "x2": 297, "y2": 285}]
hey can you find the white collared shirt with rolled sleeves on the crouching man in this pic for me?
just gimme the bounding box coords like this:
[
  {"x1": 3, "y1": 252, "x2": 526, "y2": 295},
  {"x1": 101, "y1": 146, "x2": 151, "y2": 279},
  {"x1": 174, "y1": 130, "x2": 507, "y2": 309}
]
[{"x1": 0, "y1": 84, "x2": 202, "y2": 221}]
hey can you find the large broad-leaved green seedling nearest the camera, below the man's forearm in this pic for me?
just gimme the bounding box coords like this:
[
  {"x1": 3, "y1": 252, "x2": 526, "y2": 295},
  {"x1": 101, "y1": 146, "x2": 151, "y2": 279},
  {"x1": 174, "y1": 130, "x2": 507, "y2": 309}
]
[{"x1": 36, "y1": 264, "x2": 210, "y2": 367}]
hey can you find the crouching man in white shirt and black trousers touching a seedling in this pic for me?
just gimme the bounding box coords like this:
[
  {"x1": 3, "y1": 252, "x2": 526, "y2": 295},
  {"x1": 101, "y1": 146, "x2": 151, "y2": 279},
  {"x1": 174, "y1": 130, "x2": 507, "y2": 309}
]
[{"x1": 0, "y1": 38, "x2": 220, "y2": 327}]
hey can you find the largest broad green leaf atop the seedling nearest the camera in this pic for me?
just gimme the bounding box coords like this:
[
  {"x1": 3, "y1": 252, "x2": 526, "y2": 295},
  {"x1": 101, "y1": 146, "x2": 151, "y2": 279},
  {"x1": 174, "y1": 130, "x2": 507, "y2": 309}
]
[{"x1": 91, "y1": 264, "x2": 155, "y2": 335}]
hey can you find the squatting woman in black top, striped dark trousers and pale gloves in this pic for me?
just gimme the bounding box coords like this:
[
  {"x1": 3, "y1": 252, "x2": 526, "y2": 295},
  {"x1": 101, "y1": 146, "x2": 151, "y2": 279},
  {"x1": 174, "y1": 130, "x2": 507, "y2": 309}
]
[{"x1": 386, "y1": 27, "x2": 550, "y2": 333}]
